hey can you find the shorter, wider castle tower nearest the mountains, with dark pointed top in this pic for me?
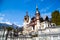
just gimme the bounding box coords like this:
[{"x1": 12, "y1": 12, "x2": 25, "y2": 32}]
[{"x1": 23, "y1": 12, "x2": 31, "y2": 35}]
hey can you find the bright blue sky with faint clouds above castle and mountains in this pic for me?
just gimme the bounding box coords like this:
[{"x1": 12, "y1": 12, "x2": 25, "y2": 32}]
[{"x1": 0, "y1": 0, "x2": 60, "y2": 25}]
